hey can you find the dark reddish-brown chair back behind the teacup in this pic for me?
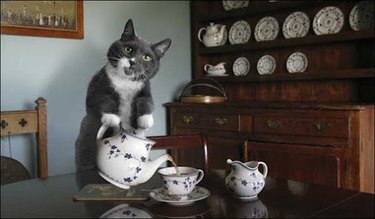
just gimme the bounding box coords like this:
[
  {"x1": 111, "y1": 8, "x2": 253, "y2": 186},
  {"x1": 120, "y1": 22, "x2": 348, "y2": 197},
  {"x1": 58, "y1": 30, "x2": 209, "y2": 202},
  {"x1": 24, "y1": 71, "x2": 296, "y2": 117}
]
[{"x1": 148, "y1": 133, "x2": 210, "y2": 172}]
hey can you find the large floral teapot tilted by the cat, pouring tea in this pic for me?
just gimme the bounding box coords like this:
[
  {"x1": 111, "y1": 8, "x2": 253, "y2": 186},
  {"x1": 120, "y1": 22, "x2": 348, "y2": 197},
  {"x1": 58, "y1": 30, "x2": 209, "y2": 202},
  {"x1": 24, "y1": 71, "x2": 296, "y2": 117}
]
[{"x1": 96, "y1": 124, "x2": 172, "y2": 189}]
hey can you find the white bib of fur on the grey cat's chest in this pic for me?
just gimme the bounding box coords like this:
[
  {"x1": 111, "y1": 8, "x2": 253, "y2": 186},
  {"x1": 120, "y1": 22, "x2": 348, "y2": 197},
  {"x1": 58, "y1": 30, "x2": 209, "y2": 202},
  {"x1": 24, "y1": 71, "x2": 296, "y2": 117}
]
[{"x1": 106, "y1": 63, "x2": 144, "y2": 130}]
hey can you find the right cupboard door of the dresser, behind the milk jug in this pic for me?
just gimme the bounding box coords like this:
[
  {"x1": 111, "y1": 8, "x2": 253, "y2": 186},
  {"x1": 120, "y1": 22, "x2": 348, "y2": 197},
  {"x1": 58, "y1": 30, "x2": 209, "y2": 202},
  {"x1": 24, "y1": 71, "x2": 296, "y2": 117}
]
[{"x1": 246, "y1": 142, "x2": 342, "y2": 187}]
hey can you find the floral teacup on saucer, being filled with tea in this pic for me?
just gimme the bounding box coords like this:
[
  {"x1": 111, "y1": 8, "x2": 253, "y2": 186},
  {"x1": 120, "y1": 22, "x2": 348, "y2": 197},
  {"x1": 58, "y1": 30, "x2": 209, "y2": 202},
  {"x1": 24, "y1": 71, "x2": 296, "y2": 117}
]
[{"x1": 158, "y1": 166, "x2": 204, "y2": 200}]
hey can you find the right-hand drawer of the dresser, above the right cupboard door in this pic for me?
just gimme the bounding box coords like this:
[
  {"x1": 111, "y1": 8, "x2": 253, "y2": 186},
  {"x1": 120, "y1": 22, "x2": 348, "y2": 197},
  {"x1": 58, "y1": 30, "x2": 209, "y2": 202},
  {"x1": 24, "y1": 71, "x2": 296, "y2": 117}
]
[{"x1": 253, "y1": 115, "x2": 349, "y2": 138}]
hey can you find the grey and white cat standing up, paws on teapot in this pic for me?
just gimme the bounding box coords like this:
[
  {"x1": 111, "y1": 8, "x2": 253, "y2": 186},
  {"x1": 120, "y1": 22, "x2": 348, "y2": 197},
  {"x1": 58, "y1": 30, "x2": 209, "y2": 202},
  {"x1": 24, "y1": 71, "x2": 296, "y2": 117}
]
[{"x1": 75, "y1": 19, "x2": 172, "y2": 172}]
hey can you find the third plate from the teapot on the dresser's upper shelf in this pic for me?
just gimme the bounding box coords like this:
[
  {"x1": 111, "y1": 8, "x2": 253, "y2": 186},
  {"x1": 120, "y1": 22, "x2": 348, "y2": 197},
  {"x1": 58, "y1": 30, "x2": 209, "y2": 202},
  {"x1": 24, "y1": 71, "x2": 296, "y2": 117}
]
[{"x1": 283, "y1": 11, "x2": 310, "y2": 39}]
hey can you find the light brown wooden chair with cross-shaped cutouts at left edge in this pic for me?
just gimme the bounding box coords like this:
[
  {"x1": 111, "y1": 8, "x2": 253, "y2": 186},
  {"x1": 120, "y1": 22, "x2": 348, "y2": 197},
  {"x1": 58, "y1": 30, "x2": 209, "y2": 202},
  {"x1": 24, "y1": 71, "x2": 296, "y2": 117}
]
[{"x1": 1, "y1": 97, "x2": 48, "y2": 178}]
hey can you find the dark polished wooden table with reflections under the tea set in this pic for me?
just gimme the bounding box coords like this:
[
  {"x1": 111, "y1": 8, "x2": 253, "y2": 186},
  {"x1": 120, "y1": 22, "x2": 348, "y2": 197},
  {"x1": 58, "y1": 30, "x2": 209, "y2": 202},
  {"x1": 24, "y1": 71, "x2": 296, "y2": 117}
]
[{"x1": 1, "y1": 171, "x2": 374, "y2": 218}]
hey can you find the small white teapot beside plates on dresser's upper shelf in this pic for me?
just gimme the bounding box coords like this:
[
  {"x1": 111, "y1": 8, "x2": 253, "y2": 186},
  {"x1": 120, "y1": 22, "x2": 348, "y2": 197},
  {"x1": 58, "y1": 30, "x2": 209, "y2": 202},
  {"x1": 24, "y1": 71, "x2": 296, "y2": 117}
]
[{"x1": 198, "y1": 23, "x2": 228, "y2": 47}]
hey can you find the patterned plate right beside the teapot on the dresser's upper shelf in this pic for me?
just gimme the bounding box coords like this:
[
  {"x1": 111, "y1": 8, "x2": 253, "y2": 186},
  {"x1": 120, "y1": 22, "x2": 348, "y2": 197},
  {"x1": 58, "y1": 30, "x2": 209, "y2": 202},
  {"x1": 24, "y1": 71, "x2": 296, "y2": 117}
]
[{"x1": 229, "y1": 20, "x2": 251, "y2": 44}]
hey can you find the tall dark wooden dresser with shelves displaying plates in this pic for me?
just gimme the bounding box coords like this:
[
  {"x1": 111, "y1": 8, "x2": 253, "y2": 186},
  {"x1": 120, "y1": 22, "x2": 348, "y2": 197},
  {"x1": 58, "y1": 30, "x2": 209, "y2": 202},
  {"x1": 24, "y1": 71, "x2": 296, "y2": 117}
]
[{"x1": 165, "y1": 1, "x2": 375, "y2": 193}]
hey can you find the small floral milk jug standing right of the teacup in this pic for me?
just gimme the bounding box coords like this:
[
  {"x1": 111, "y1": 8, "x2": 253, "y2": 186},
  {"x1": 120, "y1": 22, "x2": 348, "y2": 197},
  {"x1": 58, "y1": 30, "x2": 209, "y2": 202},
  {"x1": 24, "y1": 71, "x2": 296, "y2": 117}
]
[{"x1": 225, "y1": 159, "x2": 268, "y2": 200}]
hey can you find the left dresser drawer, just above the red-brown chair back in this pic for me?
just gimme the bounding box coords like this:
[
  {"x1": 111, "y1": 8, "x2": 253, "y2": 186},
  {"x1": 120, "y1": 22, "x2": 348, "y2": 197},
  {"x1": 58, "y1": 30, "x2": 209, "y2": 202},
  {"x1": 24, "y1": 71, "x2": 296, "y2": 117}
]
[{"x1": 172, "y1": 112, "x2": 239, "y2": 131}]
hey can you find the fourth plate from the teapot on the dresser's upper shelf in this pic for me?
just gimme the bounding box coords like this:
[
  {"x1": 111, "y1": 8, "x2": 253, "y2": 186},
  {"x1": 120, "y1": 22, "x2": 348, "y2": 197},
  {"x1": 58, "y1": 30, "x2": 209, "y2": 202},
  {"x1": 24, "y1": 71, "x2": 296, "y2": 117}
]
[{"x1": 313, "y1": 6, "x2": 344, "y2": 35}]
